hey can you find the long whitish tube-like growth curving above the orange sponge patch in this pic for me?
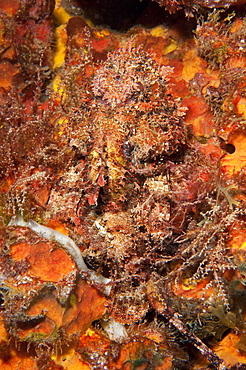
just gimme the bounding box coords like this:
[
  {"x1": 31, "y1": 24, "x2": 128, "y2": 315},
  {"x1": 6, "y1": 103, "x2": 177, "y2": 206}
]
[{"x1": 8, "y1": 216, "x2": 111, "y2": 295}]
